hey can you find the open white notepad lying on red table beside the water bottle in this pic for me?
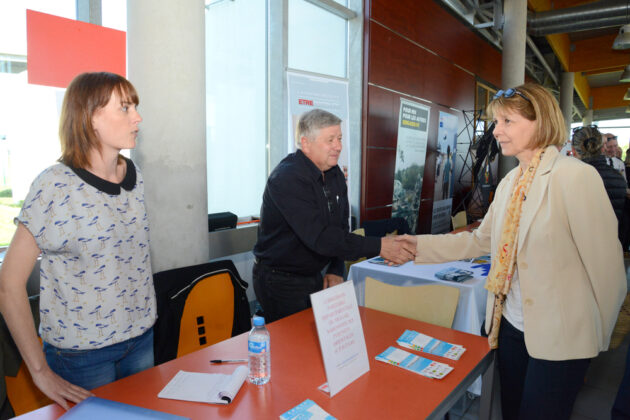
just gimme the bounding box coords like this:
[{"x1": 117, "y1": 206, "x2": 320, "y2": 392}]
[{"x1": 158, "y1": 366, "x2": 248, "y2": 404}]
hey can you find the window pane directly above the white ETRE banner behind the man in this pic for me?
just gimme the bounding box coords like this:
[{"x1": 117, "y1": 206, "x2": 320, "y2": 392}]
[{"x1": 288, "y1": 0, "x2": 348, "y2": 77}]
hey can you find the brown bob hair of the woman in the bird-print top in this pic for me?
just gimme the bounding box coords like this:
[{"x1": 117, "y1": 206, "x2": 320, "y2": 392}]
[{"x1": 59, "y1": 72, "x2": 140, "y2": 168}]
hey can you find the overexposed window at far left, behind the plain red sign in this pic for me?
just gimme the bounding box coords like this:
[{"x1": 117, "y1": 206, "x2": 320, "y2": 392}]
[{"x1": 0, "y1": 0, "x2": 76, "y2": 246}]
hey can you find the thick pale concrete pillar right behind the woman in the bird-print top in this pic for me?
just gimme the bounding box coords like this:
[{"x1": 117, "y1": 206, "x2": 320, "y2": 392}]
[{"x1": 127, "y1": 0, "x2": 210, "y2": 272}]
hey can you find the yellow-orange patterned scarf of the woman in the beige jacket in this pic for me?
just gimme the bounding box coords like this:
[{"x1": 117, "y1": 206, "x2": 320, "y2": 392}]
[{"x1": 485, "y1": 149, "x2": 544, "y2": 349}]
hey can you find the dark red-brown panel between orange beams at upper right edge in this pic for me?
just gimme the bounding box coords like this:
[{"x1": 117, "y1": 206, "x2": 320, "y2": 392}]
[{"x1": 569, "y1": 34, "x2": 630, "y2": 72}]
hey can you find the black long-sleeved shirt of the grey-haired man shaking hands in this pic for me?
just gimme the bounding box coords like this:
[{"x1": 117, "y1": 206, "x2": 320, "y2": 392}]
[{"x1": 254, "y1": 150, "x2": 381, "y2": 276}]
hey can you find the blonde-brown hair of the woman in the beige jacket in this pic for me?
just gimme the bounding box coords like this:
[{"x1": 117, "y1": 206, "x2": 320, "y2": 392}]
[{"x1": 486, "y1": 83, "x2": 567, "y2": 149}]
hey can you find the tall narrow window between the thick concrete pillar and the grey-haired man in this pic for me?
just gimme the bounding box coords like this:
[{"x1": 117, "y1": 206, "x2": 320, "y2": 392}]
[{"x1": 206, "y1": 0, "x2": 267, "y2": 217}]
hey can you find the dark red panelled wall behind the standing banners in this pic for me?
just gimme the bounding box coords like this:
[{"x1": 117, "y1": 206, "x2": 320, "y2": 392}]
[{"x1": 360, "y1": 0, "x2": 501, "y2": 233}]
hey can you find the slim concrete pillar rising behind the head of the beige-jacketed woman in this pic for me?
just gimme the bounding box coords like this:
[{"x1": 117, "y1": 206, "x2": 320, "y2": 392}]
[{"x1": 499, "y1": 0, "x2": 527, "y2": 178}]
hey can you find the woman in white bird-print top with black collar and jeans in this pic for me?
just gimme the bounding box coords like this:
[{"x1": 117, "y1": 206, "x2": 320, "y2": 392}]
[{"x1": 0, "y1": 73, "x2": 156, "y2": 409}]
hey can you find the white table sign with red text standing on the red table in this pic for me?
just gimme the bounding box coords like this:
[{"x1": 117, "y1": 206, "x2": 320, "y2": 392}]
[{"x1": 311, "y1": 281, "x2": 370, "y2": 397}]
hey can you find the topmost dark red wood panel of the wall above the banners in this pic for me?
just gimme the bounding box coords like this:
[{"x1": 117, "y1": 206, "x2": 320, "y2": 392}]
[{"x1": 370, "y1": 0, "x2": 501, "y2": 86}]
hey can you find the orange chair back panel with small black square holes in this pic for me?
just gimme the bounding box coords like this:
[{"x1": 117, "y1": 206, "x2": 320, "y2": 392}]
[{"x1": 177, "y1": 272, "x2": 234, "y2": 357}]
